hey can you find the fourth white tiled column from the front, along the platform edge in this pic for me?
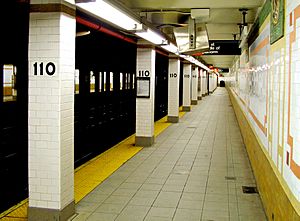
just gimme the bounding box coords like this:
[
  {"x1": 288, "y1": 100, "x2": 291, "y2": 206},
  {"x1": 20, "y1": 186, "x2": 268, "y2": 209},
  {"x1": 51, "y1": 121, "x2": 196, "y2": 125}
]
[{"x1": 182, "y1": 63, "x2": 192, "y2": 111}]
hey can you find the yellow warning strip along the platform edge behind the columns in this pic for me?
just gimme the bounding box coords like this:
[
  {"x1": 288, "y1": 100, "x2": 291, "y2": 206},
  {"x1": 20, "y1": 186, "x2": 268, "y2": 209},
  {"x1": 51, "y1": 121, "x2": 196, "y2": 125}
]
[{"x1": 0, "y1": 107, "x2": 185, "y2": 221}]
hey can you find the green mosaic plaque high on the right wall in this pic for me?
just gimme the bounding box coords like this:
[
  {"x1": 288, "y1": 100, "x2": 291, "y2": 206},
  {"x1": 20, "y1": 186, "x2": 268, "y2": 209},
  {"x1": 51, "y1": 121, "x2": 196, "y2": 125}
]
[{"x1": 270, "y1": 0, "x2": 284, "y2": 44}]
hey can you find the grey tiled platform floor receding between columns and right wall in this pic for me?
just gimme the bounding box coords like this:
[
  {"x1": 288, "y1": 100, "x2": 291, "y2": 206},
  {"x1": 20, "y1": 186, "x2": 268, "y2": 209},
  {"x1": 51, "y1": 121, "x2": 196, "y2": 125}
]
[{"x1": 72, "y1": 88, "x2": 267, "y2": 221}]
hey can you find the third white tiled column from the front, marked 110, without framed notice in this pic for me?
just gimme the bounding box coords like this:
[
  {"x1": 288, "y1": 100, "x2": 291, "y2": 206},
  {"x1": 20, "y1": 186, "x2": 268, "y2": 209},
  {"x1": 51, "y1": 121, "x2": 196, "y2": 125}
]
[{"x1": 168, "y1": 57, "x2": 180, "y2": 123}]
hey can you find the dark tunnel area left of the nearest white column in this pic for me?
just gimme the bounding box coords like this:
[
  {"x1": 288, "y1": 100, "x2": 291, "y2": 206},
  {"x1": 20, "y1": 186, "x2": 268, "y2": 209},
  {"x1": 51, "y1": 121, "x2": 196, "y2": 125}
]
[{"x1": 0, "y1": 0, "x2": 29, "y2": 213}]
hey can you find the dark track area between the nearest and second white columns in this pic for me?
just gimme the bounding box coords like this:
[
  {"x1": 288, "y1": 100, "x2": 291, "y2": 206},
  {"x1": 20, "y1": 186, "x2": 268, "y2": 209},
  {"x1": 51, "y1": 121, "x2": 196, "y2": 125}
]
[{"x1": 75, "y1": 24, "x2": 136, "y2": 166}]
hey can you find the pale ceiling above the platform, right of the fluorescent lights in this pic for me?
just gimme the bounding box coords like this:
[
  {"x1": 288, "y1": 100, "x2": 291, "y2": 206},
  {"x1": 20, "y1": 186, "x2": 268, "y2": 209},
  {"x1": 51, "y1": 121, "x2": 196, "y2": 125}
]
[{"x1": 120, "y1": 0, "x2": 265, "y2": 68}]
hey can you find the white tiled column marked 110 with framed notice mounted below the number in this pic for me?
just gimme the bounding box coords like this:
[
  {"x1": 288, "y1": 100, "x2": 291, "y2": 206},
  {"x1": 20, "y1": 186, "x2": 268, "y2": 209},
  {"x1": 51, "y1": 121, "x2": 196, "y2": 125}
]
[{"x1": 135, "y1": 45, "x2": 155, "y2": 146}]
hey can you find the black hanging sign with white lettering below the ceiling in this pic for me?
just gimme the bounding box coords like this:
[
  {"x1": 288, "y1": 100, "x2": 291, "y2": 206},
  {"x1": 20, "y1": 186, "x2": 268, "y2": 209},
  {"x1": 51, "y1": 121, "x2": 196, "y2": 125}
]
[{"x1": 202, "y1": 40, "x2": 241, "y2": 55}]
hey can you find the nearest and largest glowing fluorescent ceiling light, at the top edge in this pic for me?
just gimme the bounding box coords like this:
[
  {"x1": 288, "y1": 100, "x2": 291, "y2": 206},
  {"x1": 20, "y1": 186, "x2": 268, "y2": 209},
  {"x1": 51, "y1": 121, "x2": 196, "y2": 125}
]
[{"x1": 76, "y1": 0, "x2": 142, "y2": 30}]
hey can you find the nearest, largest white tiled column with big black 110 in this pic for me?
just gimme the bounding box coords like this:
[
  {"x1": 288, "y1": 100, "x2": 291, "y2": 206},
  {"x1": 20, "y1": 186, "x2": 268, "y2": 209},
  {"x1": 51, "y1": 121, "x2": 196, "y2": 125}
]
[{"x1": 28, "y1": 0, "x2": 76, "y2": 221}]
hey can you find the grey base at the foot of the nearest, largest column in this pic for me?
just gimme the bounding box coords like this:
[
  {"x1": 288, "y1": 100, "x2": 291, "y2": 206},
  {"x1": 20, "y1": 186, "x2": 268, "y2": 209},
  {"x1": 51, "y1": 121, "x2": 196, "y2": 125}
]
[{"x1": 28, "y1": 201, "x2": 75, "y2": 221}]
